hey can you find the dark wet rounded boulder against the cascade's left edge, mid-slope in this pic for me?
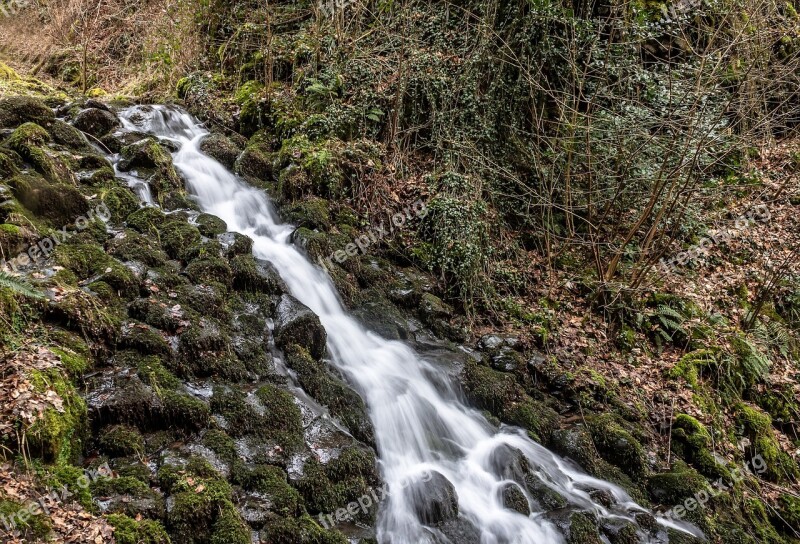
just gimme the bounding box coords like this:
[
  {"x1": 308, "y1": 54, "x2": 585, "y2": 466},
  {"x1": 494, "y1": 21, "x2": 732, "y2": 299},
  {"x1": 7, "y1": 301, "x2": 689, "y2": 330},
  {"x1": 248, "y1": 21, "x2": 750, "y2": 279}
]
[{"x1": 275, "y1": 294, "x2": 328, "y2": 359}]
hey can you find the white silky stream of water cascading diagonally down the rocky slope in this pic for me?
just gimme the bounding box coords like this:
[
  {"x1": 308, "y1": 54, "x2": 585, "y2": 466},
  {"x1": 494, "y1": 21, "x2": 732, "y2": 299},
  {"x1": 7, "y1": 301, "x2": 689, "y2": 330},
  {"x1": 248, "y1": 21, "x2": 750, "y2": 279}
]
[{"x1": 115, "y1": 106, "x2": 699, "y2": 544}]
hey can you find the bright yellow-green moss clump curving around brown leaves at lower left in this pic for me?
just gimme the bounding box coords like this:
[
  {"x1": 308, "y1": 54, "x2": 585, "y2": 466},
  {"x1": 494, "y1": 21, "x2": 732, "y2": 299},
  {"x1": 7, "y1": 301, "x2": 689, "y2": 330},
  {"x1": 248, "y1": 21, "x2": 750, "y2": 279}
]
[{"x1": 26, "y1": 368, "x2": 87, "y2": 461}]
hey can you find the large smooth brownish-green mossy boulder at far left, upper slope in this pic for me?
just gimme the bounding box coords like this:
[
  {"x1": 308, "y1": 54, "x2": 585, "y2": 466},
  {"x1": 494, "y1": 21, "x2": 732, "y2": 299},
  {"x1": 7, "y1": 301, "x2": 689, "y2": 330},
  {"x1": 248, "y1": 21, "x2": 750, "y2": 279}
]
[{"x1": 8, "y1": 174, "x2": 89, "y2": 227}]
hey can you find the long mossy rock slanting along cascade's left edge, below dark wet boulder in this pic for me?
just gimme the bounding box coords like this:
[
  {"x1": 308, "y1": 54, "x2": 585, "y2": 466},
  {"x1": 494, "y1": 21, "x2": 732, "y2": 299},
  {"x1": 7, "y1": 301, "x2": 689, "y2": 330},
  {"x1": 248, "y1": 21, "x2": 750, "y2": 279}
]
[{"x1": 285, "y1": 344, "x2": 375, "y2": 444}]
